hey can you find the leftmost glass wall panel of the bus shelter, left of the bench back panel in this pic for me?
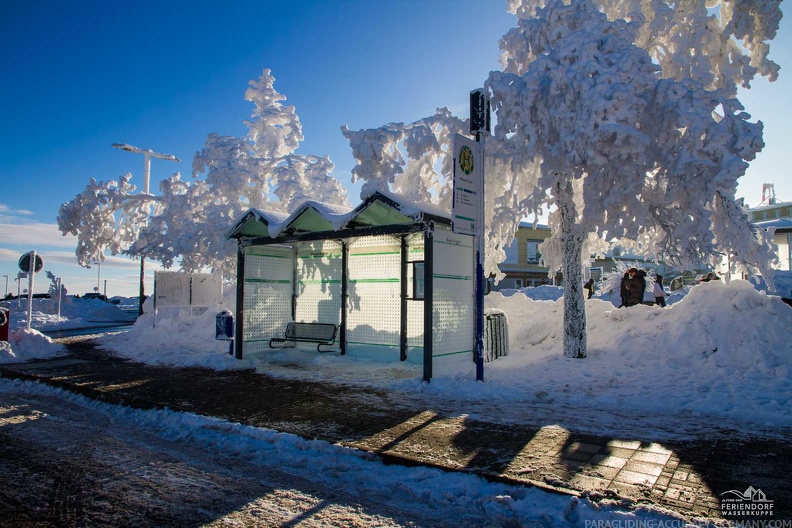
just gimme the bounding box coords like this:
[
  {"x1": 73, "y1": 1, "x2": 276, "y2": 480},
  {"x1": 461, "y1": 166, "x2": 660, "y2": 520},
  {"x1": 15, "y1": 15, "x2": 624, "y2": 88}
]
[{"x1": 242, "y1": 246, "x2": 294, "y2": 354}]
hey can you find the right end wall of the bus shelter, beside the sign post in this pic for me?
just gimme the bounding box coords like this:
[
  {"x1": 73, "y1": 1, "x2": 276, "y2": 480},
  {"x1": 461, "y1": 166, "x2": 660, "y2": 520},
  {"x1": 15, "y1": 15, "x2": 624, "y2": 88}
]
[{"x1": 432, "y1": 230, "x2": 475, "y2": 374}]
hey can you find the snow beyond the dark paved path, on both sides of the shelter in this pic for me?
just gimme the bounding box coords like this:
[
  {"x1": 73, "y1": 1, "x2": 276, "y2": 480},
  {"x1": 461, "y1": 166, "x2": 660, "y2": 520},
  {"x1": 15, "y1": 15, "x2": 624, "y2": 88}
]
[{"x1": 0, "y1": 272, "x2": 792, "y2": 435}]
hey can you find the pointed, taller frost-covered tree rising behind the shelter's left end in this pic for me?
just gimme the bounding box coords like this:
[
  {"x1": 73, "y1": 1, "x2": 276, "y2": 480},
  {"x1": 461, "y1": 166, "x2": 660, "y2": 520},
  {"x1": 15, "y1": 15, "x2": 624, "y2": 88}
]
[{"x1": 129, "y1": 70, "x2": 348, "y2": 274}]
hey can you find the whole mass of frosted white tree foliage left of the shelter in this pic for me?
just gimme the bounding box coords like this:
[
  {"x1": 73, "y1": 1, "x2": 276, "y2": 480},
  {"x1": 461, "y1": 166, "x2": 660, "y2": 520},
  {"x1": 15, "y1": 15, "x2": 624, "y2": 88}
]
[{"x1": 58, "y1": 70, "x2": 348, "y2": 275}]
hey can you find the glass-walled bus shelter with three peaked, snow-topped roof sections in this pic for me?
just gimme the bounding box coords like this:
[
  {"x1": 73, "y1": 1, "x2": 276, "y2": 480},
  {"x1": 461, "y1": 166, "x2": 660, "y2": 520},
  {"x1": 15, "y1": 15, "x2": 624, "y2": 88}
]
[{"x1": 228, "y1": 192, "x2": 475, "y2": 381}]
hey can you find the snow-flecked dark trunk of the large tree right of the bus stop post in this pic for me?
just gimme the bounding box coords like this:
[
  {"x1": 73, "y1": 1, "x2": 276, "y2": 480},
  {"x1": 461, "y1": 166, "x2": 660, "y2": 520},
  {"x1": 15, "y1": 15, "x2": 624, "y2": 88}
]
[{"x1": 556, "y1": 179, "x2": 586, "y2": 358}]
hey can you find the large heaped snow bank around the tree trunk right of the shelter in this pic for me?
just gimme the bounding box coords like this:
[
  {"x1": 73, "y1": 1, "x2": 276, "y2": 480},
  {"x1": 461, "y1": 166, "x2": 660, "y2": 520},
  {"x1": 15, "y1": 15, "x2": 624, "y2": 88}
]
[{"x1": 486, "y1": 281, "x2": 792, "y2": 427}]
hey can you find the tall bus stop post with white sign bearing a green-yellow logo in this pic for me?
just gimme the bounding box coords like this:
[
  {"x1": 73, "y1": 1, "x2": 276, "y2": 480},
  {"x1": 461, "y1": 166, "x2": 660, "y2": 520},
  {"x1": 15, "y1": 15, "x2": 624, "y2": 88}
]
[{"x1": 452, "y1": 89, "x2": 490, "y2": 381}]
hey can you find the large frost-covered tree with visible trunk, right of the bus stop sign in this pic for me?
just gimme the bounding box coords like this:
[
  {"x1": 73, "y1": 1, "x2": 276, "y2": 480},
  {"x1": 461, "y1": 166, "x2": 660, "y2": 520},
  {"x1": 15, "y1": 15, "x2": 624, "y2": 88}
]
[{"x1": 486, "y1": 0, "x2": 773, "y2": 357}]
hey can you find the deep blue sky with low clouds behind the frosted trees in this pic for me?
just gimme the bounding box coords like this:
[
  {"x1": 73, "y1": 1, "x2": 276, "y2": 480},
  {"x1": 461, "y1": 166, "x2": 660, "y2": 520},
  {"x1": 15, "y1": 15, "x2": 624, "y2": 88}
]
[{"x1": 0, "y1": 0, "x2": 792, "y2": 295}]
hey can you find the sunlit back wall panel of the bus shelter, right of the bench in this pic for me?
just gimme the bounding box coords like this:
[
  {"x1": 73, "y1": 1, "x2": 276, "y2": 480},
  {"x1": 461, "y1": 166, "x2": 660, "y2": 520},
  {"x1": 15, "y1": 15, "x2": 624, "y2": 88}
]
[{"x1": 347, "y1": 236, "x2": 401, "y2": 360}]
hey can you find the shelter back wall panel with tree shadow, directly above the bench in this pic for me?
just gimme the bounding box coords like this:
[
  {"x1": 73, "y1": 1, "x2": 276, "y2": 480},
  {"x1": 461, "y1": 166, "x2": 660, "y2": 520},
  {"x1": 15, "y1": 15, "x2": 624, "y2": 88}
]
[{"x1": 295, "y1": 240, "x2": 343, "y2": 325}]
